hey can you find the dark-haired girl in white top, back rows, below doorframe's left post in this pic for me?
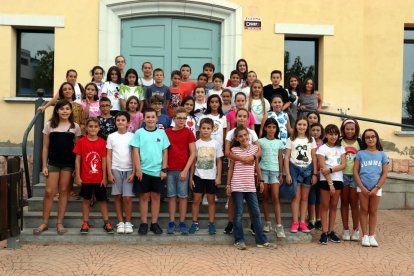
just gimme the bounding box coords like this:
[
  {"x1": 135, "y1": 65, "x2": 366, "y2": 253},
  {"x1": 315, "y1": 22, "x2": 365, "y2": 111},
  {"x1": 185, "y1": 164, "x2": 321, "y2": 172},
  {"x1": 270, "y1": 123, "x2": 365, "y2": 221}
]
[{"x1": 102, "y1": 66, "x2": 121, "y2": 116}]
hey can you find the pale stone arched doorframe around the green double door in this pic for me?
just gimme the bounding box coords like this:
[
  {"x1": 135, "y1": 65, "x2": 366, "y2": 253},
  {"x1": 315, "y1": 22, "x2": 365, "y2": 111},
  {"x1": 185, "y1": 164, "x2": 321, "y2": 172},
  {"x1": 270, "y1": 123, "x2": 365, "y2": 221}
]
[{"x1": 99, "y1": 0, "x2": 243, "y2": 76}]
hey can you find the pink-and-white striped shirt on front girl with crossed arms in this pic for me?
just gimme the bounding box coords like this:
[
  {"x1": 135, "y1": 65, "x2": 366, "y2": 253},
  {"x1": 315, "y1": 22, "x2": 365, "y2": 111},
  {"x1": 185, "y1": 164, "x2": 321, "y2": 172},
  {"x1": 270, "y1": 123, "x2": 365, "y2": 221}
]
[{"x1": 231, "y1": 145, "x2": 258, "y2": 192}]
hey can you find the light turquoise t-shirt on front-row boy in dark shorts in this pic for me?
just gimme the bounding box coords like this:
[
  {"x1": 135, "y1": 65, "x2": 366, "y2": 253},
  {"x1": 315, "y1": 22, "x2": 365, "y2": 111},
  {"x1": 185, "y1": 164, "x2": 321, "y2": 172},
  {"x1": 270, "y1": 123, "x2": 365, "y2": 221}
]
[{"x1": 129, "y1": 128, "x2": 170, "y2": 177}]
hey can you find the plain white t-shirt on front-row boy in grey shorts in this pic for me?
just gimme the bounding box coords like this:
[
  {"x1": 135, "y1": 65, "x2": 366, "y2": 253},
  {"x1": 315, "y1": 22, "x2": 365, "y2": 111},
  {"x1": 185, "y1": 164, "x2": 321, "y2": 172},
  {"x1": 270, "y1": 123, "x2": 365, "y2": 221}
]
[{"x1": 106, "y1": 131, "x2": 134, "y2": 172}]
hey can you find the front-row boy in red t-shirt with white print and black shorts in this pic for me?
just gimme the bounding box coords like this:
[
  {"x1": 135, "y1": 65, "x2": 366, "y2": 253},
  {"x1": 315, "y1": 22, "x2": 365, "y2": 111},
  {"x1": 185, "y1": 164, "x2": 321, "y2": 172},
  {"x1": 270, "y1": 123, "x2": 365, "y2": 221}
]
[{"x1": 73, "y1": 118, "x2": 114, "y2": 234}]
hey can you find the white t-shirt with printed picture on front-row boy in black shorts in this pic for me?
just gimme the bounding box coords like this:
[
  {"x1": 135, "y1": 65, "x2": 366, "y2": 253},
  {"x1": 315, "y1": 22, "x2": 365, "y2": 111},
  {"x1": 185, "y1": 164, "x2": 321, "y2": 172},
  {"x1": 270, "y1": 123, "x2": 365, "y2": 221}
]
[{"x1": 194, "y1": 139, "x2": 223, "y2": 179}]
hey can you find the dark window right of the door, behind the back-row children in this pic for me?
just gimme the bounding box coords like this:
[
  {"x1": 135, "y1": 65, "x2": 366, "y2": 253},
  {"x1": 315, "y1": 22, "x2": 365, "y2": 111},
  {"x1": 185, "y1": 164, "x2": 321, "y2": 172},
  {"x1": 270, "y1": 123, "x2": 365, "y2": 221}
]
[{"x1": 284, "y1": 38, "x2": 319, "y2": 89}]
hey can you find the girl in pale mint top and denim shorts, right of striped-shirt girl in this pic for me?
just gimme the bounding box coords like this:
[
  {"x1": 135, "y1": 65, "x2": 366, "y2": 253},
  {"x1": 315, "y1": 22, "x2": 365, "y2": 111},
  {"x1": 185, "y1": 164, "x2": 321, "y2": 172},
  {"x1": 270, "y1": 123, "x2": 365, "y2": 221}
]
[{"x1": 259, "y1": 118, "x2": 286, "y2": 238}]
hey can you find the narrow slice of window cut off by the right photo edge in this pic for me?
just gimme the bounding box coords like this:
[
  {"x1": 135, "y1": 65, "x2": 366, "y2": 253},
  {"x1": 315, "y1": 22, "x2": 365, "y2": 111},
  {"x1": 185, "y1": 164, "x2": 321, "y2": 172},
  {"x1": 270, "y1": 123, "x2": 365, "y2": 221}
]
[{"x1": 401, "y1": 29, "x2": 414, "y2": 130}]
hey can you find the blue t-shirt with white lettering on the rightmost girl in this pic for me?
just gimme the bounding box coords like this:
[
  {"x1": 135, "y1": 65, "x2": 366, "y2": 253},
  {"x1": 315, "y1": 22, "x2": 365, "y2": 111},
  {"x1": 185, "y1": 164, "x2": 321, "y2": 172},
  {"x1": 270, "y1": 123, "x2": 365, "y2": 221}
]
[{"x1": 355, "y1": 150, "x2": 389, "y2": 190}]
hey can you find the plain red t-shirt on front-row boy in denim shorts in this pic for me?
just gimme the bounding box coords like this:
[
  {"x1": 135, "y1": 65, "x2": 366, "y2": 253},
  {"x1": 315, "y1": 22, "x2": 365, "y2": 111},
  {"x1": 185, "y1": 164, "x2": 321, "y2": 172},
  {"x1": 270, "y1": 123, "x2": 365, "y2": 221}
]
[{"x1": 165, "y1": 127, "x2": 196, "y2": 171}]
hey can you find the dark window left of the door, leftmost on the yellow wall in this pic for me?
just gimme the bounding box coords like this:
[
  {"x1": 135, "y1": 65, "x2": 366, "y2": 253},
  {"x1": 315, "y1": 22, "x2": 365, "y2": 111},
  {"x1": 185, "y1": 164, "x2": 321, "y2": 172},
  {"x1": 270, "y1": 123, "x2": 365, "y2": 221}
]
[{"x1": 16, "y1": 30, "x2": 54, "y2": 97}]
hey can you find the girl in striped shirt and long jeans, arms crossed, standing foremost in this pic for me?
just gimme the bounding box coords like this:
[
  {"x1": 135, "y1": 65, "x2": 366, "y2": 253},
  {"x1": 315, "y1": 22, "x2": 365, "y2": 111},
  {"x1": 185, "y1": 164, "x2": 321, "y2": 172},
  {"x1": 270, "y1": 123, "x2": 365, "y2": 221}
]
[{"x1": 226, "y1": 126, "x2": 276, "y2": 250}]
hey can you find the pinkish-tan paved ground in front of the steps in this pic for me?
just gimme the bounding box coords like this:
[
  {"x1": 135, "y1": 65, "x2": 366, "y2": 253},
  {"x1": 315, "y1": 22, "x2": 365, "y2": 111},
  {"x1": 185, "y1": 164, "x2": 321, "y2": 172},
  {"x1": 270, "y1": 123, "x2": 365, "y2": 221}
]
[{"x1": 0, "y1": 210, "x2": 414, "y2": 275}]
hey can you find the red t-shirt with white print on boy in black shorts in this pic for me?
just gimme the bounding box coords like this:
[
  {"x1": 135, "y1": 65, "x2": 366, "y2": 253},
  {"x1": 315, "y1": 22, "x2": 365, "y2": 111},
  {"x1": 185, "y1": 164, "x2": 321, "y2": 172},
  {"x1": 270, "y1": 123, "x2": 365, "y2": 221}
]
[{"x1": 73, "y1": 137, "x2": 106, "y2": 184}]
